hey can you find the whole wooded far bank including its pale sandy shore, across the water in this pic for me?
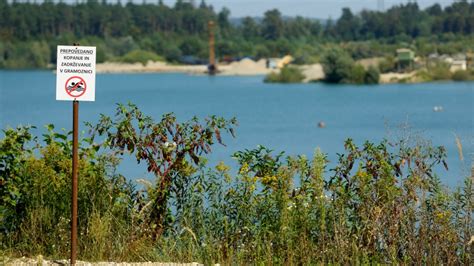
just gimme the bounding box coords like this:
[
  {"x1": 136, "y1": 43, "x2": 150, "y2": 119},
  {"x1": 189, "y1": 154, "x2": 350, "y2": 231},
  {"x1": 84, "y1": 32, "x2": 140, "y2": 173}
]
[{"x1": 0, "y1": 0, "x2": 474, "y2": 84}]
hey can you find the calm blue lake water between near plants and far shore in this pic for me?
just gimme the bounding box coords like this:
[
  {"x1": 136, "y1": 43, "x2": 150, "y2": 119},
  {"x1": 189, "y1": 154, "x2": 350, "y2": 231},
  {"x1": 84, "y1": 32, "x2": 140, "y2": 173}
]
[{"x1": 0, "y1": 71, "x2": 474, "y2": 186}]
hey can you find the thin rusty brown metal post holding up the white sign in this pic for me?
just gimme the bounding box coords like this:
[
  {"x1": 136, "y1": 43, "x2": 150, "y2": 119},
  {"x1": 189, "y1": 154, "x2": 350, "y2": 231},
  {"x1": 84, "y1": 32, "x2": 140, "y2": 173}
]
[{"x1": 71, "y1": 100, "x2": 79, "y2": 265}]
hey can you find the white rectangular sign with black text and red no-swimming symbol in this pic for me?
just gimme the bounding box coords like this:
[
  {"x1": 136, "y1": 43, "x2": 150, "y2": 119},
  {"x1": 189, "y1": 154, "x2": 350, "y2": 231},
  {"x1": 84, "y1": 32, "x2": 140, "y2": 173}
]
[{"x1": 56, "y1": 45, "x2": 96, "y2": 101}]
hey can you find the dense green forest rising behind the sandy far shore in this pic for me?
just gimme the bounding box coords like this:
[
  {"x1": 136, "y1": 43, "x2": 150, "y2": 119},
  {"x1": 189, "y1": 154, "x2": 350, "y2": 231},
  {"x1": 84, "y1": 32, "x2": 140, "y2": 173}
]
[{"x1": 0, "y1": 0, "x2": 474, "y2": 68}]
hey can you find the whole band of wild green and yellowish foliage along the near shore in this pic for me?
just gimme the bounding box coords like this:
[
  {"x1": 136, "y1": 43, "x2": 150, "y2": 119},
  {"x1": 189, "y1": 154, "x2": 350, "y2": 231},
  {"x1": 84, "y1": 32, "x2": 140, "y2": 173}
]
[{"x1": 0, "y1": 103, "x2": 473, "y2": 265}]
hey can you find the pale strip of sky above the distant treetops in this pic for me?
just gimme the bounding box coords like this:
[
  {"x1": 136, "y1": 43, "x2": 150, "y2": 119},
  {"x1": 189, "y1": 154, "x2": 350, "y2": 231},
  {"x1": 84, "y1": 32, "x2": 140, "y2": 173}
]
[{"x1": 160, "y1": 0, "x2": 455, "y2": 19}]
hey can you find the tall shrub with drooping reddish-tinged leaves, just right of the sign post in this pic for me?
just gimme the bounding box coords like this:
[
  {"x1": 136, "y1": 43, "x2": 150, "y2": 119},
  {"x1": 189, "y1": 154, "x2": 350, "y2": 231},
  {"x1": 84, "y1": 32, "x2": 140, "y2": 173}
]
[{"x1": 91, "y1": 104, "x2": 236, "y2": 239}]
